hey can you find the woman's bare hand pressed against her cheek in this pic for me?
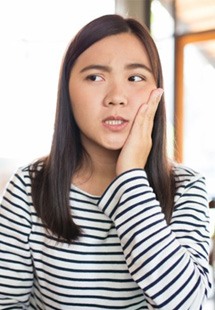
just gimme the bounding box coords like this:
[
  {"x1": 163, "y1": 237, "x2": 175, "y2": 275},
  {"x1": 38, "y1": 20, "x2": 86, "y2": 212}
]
[{"x1": 116, "y1": 88, "x2": 163, "y2": 175}]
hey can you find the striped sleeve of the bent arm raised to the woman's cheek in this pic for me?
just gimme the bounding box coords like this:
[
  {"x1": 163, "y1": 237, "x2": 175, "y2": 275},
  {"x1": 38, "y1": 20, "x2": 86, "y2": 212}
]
[{"x1": 99, "y1": 169, "x2": 210, "y2": 310}]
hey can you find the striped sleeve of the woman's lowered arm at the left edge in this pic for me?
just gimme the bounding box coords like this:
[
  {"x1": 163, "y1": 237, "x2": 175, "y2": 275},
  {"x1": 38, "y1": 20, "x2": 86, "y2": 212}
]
[{"x1": 0, "y1": 168, "x2": 33, "y2": 309}]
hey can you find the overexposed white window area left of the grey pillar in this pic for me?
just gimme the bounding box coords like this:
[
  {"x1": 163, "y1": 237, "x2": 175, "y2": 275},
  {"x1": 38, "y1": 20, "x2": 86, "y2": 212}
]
[{"x1": 0, "y1": 0, "x2": 115, "y2": 194}]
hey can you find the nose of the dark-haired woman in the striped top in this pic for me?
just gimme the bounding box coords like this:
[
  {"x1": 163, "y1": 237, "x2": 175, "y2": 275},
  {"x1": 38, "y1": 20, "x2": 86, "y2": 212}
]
[{"x1": 104, "y1": 85, "x2": 127, "y2": 106}]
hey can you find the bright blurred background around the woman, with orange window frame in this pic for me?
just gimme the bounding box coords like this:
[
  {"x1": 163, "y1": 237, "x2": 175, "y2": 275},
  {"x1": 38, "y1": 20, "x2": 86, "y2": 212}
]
[{"x1": 0, "y1": 0, "x2": 215, "y2": 310}]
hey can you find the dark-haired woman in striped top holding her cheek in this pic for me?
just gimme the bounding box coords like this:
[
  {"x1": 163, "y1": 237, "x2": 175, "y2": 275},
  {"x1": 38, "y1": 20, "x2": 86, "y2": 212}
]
[{"x1": 0, "y1": 15, "x2": 210, "y2": 310}]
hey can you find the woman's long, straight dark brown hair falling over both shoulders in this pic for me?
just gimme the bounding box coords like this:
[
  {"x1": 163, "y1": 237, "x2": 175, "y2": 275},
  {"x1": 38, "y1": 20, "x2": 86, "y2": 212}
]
[{"x1": 30, "y1": 14, "x2": 174, "y2": 242}]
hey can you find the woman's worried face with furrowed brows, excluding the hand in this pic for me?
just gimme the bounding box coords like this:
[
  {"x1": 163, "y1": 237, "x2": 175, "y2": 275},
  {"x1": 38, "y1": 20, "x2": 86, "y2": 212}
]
[{"x1": 69, "y1": 33, "x2": 157, "y2": 151}]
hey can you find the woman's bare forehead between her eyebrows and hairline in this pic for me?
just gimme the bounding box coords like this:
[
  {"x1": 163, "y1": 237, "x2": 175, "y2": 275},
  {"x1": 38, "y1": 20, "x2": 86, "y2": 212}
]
[{"x1": 76, "y1": 33, "x2": 151, "y2": 67}]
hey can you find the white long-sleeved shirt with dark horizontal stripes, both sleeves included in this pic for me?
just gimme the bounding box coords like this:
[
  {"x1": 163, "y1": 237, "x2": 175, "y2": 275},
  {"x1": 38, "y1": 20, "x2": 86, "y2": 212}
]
[{"x1": 0, "y1": 166, "x2": 210, "y2": 310}]
